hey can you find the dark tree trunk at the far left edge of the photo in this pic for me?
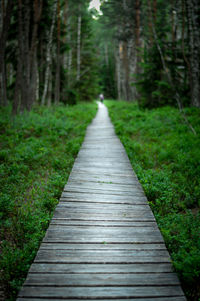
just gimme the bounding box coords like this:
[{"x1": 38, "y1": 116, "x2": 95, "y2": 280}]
[{"x1": 0, "y1": 1, "x2": 13, "y2": 105}]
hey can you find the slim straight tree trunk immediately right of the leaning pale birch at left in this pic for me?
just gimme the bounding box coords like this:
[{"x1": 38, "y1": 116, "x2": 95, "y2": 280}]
[{"x1": 55, "y1": 0, "x2": 60, "y2": 103}]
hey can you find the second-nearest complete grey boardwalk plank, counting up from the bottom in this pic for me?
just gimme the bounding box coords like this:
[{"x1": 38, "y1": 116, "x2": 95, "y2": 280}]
[{"x1": 25, "y1": 273, "x2": 180, "y2": 287}]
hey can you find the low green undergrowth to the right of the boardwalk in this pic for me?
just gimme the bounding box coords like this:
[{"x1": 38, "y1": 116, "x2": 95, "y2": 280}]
[{"x1": 106, "y1": 101, "x2": 200, "y2": 301}]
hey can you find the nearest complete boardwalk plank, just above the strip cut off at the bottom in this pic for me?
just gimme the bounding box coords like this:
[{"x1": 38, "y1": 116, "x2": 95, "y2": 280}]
[{"x1": 19, "y1": 286, "x2": 183, "y2": 299}]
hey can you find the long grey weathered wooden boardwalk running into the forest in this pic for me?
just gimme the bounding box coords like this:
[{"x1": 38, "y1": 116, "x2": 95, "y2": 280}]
[{"x1": 17, "y1": 104, "x2": 186, "y2": 301}]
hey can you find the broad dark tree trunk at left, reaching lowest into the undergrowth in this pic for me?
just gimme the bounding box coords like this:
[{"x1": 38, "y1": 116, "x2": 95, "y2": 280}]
[{"x1": 14, "y1": 0, "x2": 42, "y2": 111}]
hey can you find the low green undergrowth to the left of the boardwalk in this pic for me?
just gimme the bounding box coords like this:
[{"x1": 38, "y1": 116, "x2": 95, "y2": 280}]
[{"x1": 0, "y1": 103, "x2": 96, "y2": 300}]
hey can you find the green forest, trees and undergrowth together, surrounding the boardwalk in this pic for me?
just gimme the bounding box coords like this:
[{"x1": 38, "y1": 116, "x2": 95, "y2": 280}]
[{"x1": 0, "y1": 0, "x2": 200, "y2": 301}]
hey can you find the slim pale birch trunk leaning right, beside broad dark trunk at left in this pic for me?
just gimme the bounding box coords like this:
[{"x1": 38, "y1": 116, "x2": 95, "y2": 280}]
[{"x1": 41, "y1": 0, "x2": 58, "y2": 105}]
